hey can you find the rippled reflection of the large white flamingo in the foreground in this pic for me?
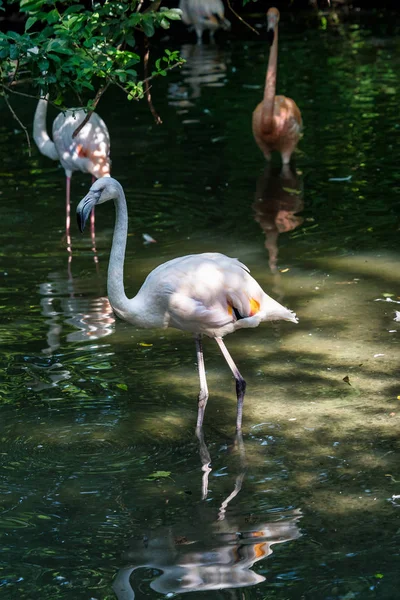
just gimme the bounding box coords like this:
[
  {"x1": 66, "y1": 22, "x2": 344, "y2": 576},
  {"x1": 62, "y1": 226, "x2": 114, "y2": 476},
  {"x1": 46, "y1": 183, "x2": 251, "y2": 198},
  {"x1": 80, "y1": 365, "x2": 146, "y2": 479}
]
[{"x1": 113, "y1": 432, "x2": 301, "y2": 600}]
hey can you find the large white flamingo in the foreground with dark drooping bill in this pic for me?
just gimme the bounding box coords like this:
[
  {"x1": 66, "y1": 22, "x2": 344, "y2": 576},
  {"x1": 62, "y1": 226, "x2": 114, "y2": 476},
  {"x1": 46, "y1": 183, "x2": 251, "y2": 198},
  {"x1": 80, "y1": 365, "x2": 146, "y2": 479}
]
[{"x1": 76, "y1": 177, "x2": 297, "y2": 431}]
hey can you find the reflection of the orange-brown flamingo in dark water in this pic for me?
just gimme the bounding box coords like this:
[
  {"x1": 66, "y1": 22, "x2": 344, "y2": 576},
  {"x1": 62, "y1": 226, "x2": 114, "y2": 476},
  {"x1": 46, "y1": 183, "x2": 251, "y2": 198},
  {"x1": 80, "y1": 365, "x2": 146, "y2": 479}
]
[{"x1": 253, "y1": 164, "x2": 304, "y2": 273}]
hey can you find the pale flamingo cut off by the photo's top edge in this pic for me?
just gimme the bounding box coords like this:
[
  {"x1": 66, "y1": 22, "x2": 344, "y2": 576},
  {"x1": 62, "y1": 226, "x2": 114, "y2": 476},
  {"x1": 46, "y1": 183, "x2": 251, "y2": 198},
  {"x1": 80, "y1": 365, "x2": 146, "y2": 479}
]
[{"x1": 179, "y1": 0, "x2": 231, "y2": 44}]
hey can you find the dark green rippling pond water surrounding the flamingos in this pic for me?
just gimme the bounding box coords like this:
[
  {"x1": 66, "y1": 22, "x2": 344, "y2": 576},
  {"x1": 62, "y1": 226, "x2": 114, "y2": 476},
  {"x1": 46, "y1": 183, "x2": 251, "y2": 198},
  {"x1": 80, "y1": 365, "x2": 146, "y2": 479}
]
[{"x1": 0, "y1": 14, "x2": 400, "y2": 600}]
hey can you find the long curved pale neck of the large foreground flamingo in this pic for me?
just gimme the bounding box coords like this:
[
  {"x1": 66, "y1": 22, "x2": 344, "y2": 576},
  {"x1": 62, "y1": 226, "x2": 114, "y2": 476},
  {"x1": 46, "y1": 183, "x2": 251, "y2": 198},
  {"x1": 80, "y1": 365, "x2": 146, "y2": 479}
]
[{"x1": 107, "y1": 187, "x2": 130, "y2": 318}]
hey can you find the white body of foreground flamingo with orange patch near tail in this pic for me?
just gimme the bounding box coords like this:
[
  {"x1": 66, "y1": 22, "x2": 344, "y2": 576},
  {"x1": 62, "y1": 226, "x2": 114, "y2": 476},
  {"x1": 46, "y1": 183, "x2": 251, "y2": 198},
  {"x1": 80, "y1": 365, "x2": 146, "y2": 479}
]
[{"x1": 116, "y1": 252, "x2": 297, "y2": 337}]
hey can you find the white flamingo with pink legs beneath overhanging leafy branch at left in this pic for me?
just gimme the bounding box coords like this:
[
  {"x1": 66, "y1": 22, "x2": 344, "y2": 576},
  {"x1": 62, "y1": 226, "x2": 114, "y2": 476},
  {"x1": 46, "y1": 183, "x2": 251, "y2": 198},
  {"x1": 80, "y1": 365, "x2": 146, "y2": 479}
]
[{"x1": 33, "y1": 96, "x2": 111, "y2": 246}]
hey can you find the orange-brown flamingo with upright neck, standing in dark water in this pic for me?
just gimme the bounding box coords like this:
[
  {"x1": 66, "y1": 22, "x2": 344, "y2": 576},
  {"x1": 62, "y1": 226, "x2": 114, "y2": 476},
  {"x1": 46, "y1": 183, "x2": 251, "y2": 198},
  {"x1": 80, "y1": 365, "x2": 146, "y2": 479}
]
[{"x1": 253, "y1": 8, "x2": 302, "y2": 165}]
